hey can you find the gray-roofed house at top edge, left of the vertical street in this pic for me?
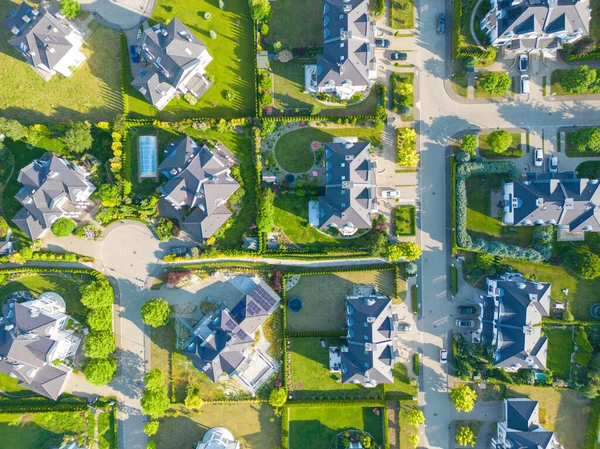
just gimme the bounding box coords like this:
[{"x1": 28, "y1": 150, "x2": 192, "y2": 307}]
[{"x1": 305, "y1": 0, "x2": 377, "y2": 100}]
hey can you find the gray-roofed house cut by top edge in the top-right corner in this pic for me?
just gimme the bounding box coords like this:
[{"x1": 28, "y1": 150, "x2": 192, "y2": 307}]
[{"x1": 481, "y1": 0, "x2": 591, "y2": 58}]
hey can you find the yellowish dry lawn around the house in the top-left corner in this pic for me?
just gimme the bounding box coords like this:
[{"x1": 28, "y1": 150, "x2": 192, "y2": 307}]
[{"x1": 0, "y1": 5, "x2": 122, "y2": 124}]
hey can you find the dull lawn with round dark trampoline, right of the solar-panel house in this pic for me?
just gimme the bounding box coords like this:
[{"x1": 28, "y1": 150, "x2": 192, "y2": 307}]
[{"x1": 287, "y1": 270, "x2": 394, "y2": 332}]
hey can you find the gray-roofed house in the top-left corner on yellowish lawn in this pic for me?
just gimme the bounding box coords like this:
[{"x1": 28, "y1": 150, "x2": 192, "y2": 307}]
[{"x1": 5, "y1": 3, "x2": 73, "y2": 76}]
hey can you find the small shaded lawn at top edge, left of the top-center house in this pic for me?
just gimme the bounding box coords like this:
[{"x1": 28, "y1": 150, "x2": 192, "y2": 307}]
[{"x1": 266, "y1": 0, "x2": 323, "y2": 48}]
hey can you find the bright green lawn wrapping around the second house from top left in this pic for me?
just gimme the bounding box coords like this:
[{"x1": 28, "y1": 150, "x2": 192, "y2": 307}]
[{"x1": 126, "y1": 0, "x2": 255, "y2": 121}]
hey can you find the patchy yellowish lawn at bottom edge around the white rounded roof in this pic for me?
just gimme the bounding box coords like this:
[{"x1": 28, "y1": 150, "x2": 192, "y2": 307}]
[{"x1": 155, "y1": 403, "x2": 281, "y2": 449}]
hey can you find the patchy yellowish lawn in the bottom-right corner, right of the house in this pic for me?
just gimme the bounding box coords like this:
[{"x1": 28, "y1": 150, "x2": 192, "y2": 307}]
[{"x1": 509, "y1": 385, "x2": 591, "y2": 449}]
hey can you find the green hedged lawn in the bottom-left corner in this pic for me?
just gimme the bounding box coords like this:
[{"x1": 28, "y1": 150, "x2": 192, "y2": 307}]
[{"x1": 0, "y1": 411, "x2": 88, "y2": 449}]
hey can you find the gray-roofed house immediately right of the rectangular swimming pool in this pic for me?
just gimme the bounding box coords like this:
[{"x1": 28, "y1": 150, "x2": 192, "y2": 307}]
[{"x1": 158, "y1": 136, "x2": 240, "y2": 240}]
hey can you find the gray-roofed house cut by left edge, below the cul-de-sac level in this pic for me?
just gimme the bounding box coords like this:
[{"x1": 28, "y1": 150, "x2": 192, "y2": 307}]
[{"x1": 0, "y1": 292, "x2": 81, "y2": 400}]
